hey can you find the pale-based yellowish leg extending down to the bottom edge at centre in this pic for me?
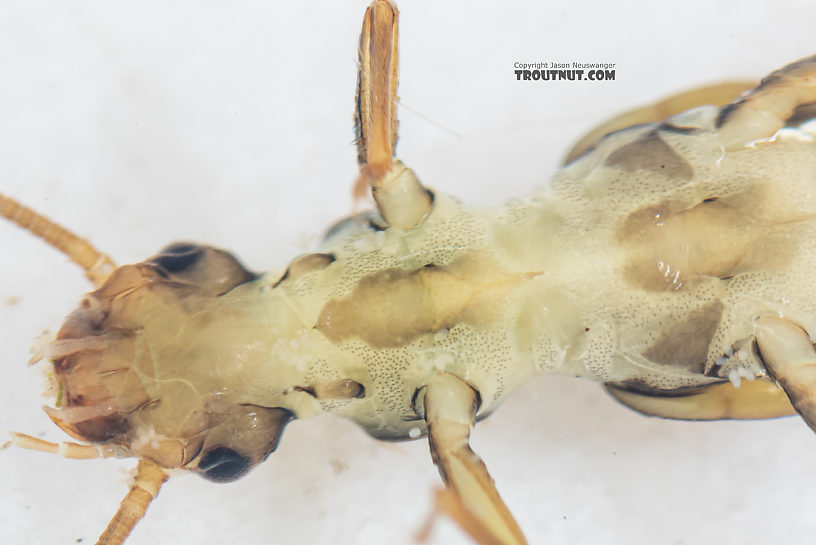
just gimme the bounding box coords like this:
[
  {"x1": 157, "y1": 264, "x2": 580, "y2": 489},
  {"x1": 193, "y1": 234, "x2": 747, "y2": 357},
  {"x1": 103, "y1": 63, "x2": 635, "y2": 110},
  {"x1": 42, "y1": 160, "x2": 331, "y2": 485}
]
[{"x1": 424, "y1": 373, "x2": 527, "y2": 545}]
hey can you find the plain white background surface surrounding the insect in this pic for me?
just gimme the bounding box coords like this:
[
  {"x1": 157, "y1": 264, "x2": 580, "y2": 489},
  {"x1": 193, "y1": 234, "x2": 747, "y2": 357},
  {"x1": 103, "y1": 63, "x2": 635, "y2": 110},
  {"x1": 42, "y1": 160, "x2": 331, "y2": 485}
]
[{"x1": 0, "y1": 0, "x2": 816, "y2": 545}]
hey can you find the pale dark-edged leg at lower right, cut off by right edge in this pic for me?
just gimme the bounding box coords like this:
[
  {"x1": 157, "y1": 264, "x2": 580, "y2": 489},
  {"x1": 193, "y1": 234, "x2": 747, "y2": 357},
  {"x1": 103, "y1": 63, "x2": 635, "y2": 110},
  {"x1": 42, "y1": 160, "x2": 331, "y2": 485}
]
[{"x1": 756, "y1": 316, "x2": 816, "y2": 431}]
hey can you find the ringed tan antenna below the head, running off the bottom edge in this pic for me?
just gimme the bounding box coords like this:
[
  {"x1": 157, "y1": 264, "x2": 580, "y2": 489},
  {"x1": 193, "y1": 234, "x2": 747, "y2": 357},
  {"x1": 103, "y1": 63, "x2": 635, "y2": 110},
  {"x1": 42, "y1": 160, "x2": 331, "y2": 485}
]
[{"x1": 96, "y1": 460, "x2": 168, "y2": 545}]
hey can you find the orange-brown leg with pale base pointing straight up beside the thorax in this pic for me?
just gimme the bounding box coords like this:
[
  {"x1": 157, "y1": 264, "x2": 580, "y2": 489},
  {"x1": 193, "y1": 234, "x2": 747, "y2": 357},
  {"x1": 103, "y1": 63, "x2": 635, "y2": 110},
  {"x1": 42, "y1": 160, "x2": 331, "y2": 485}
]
[{"x1": 355, "y1": 0, "x2": 431, "y2": 230}]
